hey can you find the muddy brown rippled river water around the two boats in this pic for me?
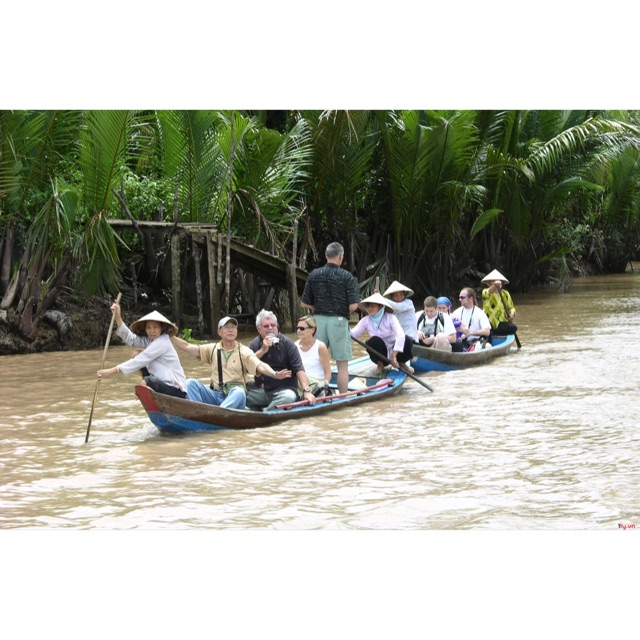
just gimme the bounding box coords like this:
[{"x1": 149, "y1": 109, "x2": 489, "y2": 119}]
[{"x1": 0, "y1": 272, "x2": 640, "y2": 637}]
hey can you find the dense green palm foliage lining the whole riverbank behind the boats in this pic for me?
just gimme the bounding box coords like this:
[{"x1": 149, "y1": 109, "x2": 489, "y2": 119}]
[{"x1": 0, "y1": 110, "x2": 640, "y2": 338}]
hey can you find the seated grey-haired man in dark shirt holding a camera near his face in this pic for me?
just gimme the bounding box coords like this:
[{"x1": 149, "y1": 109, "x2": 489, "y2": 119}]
[{"x1": 247, "y1": 309, "x2": 316, "y2": 411}]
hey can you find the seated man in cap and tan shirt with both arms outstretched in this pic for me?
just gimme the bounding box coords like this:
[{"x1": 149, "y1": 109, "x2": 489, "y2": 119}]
[{"x1": 171, "y1": 316, "x2": 291, "y2": 409}]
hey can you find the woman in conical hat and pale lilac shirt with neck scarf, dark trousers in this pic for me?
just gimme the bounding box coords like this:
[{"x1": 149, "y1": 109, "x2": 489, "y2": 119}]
[{"x1": 351, "y1": 293, "x2": 413, "y2": 373}]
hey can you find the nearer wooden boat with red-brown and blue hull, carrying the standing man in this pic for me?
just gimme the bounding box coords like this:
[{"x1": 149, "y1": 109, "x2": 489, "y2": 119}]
[{"x1": 135, "y1": 364, "x2": 407, "y2": 434}]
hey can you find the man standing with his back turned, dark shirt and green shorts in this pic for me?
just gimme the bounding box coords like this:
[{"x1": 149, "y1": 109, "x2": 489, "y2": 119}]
[{"x1": 301, "y1": 242, "x2": 360, "y2": 393}]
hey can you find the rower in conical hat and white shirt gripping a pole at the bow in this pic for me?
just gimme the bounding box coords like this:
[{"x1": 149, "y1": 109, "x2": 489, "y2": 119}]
[{"x1": 98, "y1": 303, "x2": 187, "y2": 398}]
